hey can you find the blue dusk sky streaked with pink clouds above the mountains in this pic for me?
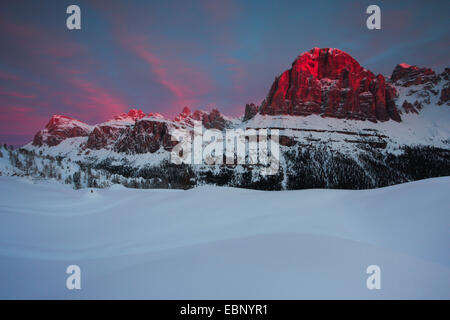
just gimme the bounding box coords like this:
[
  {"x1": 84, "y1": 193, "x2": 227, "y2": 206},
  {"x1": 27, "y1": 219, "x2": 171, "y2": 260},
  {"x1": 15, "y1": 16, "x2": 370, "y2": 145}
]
[{"x1": 0, "y1": 0, "x2": 450, "y2": 146}]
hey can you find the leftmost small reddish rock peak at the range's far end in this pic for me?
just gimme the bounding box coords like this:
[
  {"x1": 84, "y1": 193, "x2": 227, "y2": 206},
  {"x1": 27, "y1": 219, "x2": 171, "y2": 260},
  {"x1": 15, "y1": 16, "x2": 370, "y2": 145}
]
[{"x1": 33, "y1": 115, "x2": 91, "y2": 147}]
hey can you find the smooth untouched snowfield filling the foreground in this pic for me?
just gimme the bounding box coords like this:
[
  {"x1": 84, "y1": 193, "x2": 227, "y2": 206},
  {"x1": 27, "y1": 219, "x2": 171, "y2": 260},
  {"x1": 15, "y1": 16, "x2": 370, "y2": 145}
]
[{"x1": 0, "y1": 177, "x2": 450, "y2": 299}]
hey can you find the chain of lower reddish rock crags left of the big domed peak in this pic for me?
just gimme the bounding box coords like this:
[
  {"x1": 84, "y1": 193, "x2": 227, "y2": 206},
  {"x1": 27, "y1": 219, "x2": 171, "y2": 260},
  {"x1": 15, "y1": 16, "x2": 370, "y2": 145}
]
[{"x1": 33, "y1": 107, "x2": 230, "y2": 154}]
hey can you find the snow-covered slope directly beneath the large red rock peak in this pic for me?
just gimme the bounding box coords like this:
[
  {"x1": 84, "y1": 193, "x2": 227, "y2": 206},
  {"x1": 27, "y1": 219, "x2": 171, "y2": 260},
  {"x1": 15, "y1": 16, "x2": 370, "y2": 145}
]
[{"x1": 245, "y1": 101, "x2": 450, "y2": 152}]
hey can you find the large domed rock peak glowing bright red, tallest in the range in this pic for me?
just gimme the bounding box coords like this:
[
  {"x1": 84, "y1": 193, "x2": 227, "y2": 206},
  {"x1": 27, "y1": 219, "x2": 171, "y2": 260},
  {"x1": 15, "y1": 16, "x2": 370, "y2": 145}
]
[{"x1": 259, "y1": 48, "x2": 401, "y2": 122}]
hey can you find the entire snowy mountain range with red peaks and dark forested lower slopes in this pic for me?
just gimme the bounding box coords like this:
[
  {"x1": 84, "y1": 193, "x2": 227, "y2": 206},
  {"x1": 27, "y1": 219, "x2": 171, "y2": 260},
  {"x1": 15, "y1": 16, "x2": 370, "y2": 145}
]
[{"x1": 0, "y1": 48, "x2": 450, "y2": 190}]
